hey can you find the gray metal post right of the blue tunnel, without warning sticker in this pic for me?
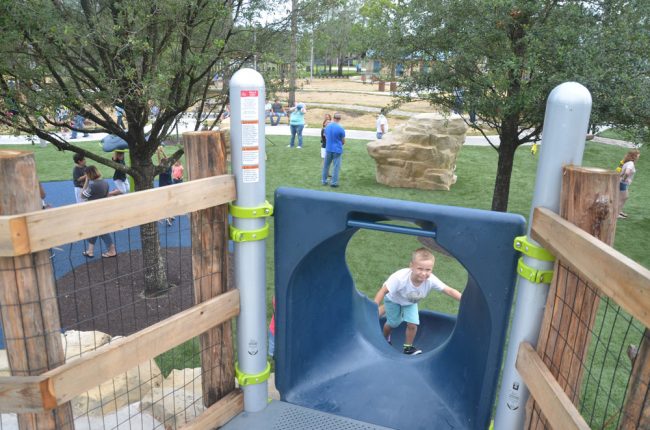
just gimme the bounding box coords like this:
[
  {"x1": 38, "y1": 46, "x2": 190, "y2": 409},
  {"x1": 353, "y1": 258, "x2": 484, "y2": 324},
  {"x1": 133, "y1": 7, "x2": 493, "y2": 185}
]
[{"x1": 494, "y1": 82, "x2": 591, "y2": 430}]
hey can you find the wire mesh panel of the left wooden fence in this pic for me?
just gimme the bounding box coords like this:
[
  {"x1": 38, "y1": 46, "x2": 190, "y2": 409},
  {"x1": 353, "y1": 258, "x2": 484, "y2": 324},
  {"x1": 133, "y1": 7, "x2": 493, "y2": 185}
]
[{"x1": 0, "y1": 207, "x2": 232, "y2": 430}]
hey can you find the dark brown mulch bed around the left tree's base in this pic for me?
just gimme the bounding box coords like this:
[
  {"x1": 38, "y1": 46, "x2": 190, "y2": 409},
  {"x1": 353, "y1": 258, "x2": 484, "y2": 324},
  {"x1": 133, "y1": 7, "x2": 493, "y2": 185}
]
[{"x1": 57, "y1": 248, "x2": 218, "y2": 336}]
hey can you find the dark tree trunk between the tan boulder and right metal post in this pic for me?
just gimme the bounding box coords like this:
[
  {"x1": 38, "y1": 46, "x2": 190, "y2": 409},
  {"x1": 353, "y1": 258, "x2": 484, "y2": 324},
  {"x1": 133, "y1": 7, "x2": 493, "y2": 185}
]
[{"x1": 492, "y1": 119, "x2": 519, "y2": 212}]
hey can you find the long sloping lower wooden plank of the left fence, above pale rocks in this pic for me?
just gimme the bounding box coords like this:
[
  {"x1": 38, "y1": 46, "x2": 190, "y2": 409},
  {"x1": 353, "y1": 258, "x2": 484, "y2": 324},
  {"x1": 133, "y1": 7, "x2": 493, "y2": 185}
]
[{"x1": 42, "y1": 290, "x2": 239, "y2": 409}]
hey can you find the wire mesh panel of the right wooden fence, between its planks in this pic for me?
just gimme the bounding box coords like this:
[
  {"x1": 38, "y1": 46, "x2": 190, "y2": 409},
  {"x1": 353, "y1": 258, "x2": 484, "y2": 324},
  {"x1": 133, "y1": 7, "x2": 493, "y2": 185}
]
[{"x1": 527, "y1": 262, "x2": 647, "y2": 429}]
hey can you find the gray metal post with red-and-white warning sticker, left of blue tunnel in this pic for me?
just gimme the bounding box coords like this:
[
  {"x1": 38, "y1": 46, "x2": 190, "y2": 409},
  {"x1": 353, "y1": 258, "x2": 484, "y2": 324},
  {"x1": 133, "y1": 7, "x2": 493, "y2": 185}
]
[{"x1": 230, "y1": 69, "x2": 268, "y2": 412}]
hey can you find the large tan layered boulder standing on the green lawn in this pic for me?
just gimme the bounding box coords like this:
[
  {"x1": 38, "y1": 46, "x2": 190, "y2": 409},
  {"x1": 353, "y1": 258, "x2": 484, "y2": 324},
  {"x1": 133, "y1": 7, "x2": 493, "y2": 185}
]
[{"x1": 367, "y1": 113, "x2": 467, "y2": 191}]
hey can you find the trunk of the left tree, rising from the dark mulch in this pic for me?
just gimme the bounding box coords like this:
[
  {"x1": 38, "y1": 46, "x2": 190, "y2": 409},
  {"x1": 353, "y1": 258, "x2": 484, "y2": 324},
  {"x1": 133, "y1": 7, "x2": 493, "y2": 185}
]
[{"x1": 131, "y1": 153, "x2": 169, "y2": 297}]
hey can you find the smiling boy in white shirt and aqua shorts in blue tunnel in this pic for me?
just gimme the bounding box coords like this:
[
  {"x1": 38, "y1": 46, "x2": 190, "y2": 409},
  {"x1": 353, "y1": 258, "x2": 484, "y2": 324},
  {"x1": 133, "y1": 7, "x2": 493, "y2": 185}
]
[{"x1": 375, "y1": 248, "x2": 461, "y2": 355}]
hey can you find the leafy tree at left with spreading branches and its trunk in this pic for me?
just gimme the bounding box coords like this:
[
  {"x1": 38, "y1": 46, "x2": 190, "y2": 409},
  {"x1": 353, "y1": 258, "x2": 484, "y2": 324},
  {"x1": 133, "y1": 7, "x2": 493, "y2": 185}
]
[{"x1": 0, "y1": 0, "x2": 264, "y2": 293}]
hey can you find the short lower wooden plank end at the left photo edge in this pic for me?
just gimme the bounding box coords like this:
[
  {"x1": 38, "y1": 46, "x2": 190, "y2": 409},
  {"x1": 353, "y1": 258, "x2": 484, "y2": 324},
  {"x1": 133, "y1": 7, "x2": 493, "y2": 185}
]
[{"x1": 0, "y1": 375, "x2": 47, "y2": 413}]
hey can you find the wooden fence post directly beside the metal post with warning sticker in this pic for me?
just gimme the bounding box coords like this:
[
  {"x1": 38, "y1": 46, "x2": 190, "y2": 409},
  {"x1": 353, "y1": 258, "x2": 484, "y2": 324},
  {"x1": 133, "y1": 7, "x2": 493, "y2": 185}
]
[{"x1": 183, "y1": 131, "x2": 235, "y2": 407}]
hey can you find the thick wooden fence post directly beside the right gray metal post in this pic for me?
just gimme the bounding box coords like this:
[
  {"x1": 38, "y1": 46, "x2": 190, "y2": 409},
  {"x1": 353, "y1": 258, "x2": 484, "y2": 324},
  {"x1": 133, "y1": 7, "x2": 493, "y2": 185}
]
[{"x1": 525, "y1": 166, "x2": 619, "y2": 429}]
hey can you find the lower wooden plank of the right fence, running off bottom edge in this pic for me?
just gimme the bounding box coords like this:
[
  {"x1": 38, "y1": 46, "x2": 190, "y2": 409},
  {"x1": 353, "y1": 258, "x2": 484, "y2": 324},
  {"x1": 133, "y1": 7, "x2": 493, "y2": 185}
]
[{"x1": 516, "y1": 342, "x2": 589, "y2": 430}]
